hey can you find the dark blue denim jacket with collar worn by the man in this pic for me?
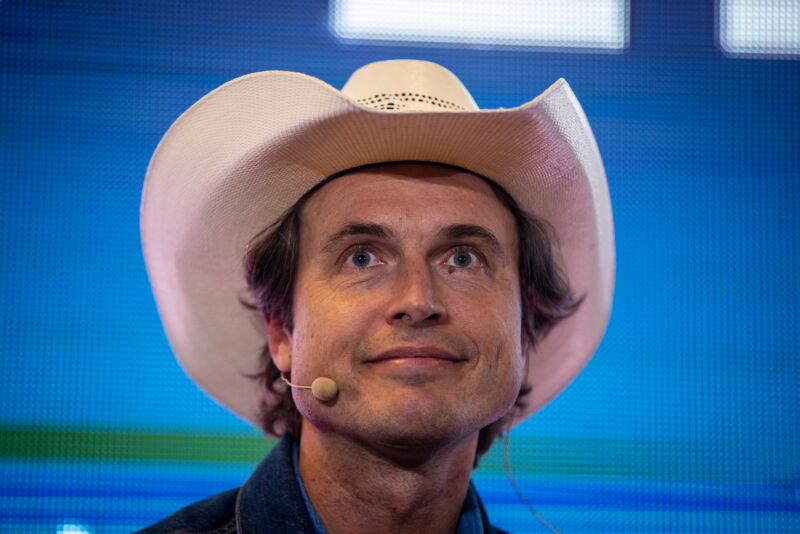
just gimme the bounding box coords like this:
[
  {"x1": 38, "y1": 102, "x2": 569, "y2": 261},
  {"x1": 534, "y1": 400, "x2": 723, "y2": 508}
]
[{"x1": 139, "y1": 437, "x2": 502, "y2": 534}]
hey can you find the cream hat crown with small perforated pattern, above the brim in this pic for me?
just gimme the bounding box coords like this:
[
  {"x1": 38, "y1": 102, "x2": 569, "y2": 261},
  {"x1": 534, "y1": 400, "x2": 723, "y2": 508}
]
[{"x1": 342, "y1": 59, "x2": 478, "y2": 111}]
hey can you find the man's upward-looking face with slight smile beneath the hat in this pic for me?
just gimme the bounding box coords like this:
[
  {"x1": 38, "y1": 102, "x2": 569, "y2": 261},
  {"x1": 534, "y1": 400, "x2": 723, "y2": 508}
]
[{"x1": 270, "y1": 163, "x2": 524, "y2": 447}]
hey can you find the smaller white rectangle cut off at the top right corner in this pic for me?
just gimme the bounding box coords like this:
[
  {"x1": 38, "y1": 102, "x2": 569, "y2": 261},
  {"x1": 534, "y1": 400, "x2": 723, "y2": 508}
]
[{"x1": 719, "y1": 0, "x2": 800, "y2": 55}]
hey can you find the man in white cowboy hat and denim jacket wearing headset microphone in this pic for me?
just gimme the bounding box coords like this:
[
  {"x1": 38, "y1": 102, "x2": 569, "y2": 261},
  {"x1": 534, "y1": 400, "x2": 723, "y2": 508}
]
[{"x1": 142, "y1": 61, "x2": 614, "y2": 533}]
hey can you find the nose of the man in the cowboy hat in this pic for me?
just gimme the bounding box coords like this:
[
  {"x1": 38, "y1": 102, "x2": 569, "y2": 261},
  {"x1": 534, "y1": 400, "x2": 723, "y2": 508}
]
[{"x1": 386, "y1": 261, "x2": 447, "y2": 326}]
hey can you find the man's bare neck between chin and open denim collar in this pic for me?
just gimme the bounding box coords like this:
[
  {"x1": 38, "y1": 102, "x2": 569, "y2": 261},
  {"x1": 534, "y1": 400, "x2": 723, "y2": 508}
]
[{"x1": 299, "y1": 424, "x2": 477, "y2": 534}]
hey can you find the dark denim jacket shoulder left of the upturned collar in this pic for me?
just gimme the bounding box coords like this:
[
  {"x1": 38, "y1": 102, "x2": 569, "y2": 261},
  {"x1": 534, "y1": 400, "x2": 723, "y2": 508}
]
[{"x1": 134, "y1": 488, "x2": 239, "y2": 534}]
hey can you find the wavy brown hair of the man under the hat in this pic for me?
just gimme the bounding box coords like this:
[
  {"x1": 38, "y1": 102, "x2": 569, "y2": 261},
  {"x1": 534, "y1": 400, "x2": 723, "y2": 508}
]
[{"x1": 239, "y1": 162, "x2": 582, "y2": 465}]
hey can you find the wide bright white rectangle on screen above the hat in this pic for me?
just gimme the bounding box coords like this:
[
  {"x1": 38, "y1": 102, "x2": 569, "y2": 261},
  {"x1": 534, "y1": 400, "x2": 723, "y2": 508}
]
[{"x1": 330, "y1": 0, "x2": 628, "y2": 49}]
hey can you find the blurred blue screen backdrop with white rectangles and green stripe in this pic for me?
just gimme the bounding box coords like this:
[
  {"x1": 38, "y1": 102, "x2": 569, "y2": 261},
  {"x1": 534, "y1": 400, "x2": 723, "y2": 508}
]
[{"x1": 0, "y1": 0, "x2": 800, "y2": 533}]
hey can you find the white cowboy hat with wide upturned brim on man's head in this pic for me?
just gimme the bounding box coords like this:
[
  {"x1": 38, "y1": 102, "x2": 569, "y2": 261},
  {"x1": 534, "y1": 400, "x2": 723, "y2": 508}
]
[{"x1": 141, "y1": 60, "x2": 614, "y2": 432}]
